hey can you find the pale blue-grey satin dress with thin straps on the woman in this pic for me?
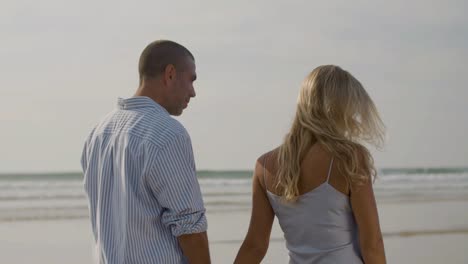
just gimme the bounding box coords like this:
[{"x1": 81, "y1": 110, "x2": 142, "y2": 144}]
[{"x1": 267, "y1": 159, "x2": 363, "y2": 264}]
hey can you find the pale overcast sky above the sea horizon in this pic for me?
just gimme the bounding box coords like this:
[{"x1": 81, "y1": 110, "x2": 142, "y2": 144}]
[{"x1": 0, "y1": 0, "x2": 468, "y2": 172}]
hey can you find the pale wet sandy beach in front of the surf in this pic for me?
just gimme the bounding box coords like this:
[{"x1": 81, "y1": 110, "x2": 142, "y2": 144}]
[{"x1": 0, "y1": 199, "x2": 468, "y2": 264}]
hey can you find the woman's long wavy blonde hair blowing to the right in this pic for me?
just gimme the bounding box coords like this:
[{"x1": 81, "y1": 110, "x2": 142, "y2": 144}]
[{"x1": 276, "y1": 65, "x2": 385, "y2": 202}]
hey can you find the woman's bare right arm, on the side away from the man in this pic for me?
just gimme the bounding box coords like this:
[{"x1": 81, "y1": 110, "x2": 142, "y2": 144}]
[{"x1": 350, "y1": 177, "x2": 386, "y2": 264}]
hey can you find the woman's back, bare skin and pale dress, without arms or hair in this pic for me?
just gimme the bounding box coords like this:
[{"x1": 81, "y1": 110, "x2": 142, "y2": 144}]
[{"x1": 263, "y1": 144, "x2": 362, "y2": 263}]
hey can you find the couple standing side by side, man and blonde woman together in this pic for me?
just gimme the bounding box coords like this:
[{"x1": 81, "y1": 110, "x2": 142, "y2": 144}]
[{"x1": 81, "y1": 40, "x2": 385, "y2": 264}]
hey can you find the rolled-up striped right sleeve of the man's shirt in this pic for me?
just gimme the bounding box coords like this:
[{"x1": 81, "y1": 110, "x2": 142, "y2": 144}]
[{"x1": 148, "y1": 134, "x2": 207, "y2": 236}]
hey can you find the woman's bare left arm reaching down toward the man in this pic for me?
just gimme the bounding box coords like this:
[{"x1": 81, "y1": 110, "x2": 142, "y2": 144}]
[{"x1": 234, "y1": 161, "x2": 275, "y2": 264}]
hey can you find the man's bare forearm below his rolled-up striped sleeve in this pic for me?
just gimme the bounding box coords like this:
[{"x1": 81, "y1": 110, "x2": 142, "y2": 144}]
[{"x1": 177, "y1": 232, "x2": 211, "y2": 264}]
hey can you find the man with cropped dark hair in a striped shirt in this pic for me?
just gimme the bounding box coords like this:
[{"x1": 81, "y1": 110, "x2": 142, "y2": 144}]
[{"x1": 81, "y1": 40, "x2": 210, "y2": 264}]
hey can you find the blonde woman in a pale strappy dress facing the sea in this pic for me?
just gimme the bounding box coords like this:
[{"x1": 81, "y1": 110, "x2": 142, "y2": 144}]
[{"x1": 235, "y1": 65, "x2": 385, "y2": 264}]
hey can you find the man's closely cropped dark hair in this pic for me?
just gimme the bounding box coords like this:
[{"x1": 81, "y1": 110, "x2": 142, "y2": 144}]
[{"x1": 138, "y1": 40, "x2": 195, "y2": 83}]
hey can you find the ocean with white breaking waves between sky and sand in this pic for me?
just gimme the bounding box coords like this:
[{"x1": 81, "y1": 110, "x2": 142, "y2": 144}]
[{"x1": 0, "y1": 168, "x2": 468, "y2": 221}]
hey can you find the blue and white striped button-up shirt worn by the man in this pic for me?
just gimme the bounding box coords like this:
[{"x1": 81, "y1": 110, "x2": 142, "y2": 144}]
[{"x1": 81, "y1": 97, "x2": 207, "y2": 264}]
